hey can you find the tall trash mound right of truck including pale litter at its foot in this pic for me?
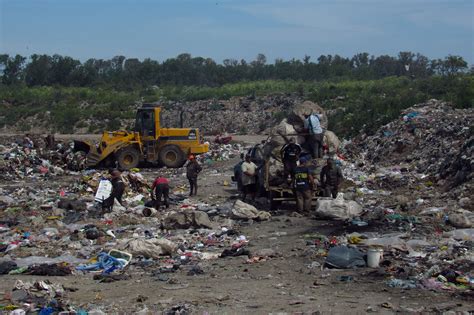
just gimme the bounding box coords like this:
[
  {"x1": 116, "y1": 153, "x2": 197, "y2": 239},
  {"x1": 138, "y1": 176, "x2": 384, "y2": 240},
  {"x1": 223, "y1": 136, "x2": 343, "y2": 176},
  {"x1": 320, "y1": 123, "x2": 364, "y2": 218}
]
[{"x1": 336, "y1": 100, "x2": 474, "y2": 233}]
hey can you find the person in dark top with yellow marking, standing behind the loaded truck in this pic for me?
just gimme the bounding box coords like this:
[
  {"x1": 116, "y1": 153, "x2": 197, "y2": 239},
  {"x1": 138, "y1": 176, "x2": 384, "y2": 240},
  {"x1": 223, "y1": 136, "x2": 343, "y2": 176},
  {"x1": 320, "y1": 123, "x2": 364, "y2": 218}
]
[{"x1": 293, "y1": 157, "x2": 314, "y2": 213}]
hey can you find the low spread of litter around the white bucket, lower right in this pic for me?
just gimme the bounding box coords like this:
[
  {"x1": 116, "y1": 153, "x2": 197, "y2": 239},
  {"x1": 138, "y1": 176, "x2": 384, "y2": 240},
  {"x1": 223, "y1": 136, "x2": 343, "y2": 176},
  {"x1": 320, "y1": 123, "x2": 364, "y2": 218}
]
[{"x1": 303, "y1": 229, "x2": 474, "y2": 296}]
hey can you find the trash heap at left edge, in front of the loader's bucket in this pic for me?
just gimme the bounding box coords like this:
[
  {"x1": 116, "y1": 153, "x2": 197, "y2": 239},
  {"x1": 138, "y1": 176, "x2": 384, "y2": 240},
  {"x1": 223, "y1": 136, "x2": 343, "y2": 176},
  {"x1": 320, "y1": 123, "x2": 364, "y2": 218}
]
[{"x1": 0, "y1": 137, "x2": 85, "y2": 180}]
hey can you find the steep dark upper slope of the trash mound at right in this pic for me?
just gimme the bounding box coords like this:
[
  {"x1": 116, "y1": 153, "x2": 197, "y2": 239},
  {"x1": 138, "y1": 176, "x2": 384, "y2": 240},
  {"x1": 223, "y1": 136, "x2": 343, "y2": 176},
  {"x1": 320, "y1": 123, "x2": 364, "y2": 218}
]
[{"x1": 345, "y1": 100, "x2": 474, "y2": 197}]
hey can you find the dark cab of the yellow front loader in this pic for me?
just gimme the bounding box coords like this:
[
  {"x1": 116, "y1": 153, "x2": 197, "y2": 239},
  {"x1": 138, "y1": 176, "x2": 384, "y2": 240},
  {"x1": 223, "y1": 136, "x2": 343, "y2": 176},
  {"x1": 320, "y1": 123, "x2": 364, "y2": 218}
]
[{"x1": 134, "y1": 104, "x2": 161, "y2": 141}]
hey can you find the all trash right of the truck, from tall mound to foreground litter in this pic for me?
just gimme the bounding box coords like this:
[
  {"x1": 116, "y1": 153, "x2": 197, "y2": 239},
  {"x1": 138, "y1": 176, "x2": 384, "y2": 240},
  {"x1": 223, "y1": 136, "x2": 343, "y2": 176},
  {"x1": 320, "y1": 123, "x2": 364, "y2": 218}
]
[{"x1": 302, "y1": 100, "x2": 474, "y2": 298}]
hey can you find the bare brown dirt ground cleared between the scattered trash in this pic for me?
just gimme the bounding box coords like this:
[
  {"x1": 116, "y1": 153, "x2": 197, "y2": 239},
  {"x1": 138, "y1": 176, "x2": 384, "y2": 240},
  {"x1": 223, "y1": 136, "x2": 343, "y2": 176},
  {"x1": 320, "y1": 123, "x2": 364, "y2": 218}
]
[{"x1": 0, "y1": 139, "x2": 474, "y2": 314}]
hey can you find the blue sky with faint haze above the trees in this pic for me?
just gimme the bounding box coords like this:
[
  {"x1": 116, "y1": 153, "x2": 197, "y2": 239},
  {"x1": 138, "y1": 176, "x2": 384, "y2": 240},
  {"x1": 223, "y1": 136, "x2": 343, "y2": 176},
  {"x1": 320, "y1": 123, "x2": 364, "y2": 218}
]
[{"x1": 0, "y1": 0, "x2": 474, "y2": 64}]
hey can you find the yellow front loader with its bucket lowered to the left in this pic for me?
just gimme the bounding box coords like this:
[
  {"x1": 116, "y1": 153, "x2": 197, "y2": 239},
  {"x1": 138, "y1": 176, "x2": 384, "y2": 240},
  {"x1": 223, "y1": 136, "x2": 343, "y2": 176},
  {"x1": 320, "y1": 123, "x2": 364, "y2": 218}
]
[{"x1": 74, "y1": 104, "x2": 209, "y2": 170}]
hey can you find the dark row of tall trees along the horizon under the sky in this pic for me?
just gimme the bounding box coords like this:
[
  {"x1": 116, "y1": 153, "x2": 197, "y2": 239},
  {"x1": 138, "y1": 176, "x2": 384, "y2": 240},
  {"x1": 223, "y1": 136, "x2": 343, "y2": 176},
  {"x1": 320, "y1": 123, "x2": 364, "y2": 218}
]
[{"x1": 0, "y1": 52, "x2": 472, "y2": 90}]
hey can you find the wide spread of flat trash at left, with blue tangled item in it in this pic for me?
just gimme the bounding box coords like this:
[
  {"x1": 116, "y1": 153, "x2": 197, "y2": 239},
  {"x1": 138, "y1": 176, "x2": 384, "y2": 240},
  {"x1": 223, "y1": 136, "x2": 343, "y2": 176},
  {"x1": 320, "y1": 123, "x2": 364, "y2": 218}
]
[{"x1": 0, "y1": 164, "x2": 273, "y2": 314}]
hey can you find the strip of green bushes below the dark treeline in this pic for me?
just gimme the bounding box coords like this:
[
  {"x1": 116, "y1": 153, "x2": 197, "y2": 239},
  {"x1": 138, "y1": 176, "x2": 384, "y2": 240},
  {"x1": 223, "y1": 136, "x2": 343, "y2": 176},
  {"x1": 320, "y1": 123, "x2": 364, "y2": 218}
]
[{"x1": 0, "y1": 74, "x2": 474, "y2": 138}]
